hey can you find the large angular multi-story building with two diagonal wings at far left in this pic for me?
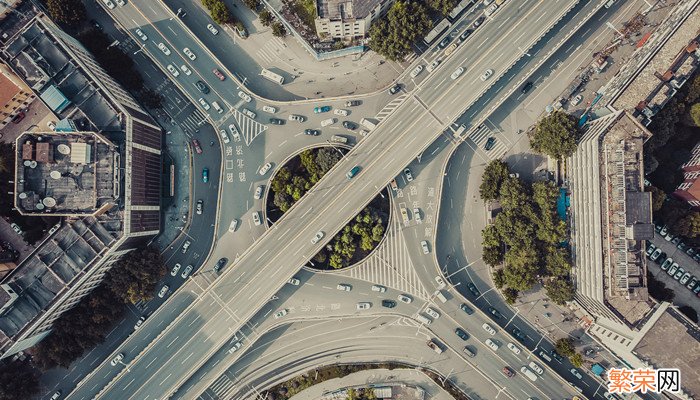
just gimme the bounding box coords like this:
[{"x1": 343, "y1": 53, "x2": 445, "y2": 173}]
[{"x1": 0, "y1": 14, "x2": 161, "y2": 358}]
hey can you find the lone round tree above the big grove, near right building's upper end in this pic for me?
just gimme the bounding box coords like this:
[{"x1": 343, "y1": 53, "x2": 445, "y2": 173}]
[{"x1": 530, "y1": 111, "x2": 580, "y2": 159}]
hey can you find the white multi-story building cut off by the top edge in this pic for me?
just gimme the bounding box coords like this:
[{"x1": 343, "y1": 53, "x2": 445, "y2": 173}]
[{"x1": 315, "y1": 0, "x2": 394, "y2": 40}]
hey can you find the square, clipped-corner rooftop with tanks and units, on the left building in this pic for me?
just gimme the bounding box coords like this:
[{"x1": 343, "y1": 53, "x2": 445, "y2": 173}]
[{"x1": 15, "y1": 132, "x2": 119, "y2": 216}]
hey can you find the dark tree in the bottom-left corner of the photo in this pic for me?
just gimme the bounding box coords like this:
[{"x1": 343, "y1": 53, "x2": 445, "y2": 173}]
[{"x1": 0, "y1": 360, "x2": 40, "y2": 400}]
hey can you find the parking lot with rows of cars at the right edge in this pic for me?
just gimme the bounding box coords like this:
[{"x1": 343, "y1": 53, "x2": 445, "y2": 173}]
[{"x1": 648, "y1": 232, "x2": 700, "y2": 315}]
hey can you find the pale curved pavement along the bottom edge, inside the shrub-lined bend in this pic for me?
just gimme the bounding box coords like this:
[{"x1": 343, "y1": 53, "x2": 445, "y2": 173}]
[{"x1": 291, "y1": 369, "x2": 452, "y2": 400}]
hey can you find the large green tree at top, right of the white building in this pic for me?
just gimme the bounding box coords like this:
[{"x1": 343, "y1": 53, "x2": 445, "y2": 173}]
[{"x1": 369, "y1": 1, "x2": 433, "y2": 61}]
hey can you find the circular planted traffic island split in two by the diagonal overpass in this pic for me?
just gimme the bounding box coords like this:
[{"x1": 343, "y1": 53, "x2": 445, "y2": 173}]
[{"x1": 266, "y1": 147, "x2": 390, "y2": 270}]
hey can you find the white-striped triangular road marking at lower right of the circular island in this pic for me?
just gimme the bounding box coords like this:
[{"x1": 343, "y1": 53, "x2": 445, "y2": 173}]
[{"x1": 341, "y1": 218, "x2": 430, "y2": 299}]
